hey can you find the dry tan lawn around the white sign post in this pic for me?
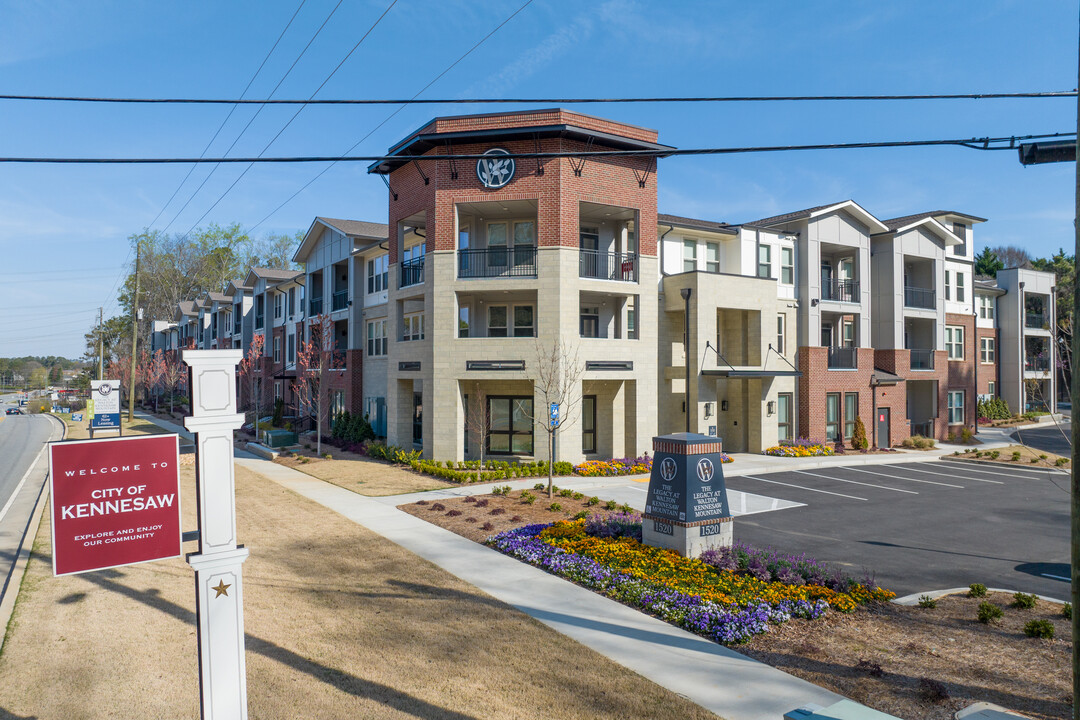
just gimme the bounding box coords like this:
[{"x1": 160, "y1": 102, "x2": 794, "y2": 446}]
[{"x1": 0, "y1": 465, "x2": 715, "y2": 720}]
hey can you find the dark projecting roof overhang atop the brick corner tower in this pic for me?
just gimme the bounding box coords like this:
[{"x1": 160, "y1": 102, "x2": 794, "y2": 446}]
[{"x1": 367, "y1": 124, "x2": 675, "y2": 175}]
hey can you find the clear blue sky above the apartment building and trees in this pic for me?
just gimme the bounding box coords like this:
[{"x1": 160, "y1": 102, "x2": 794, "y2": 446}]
[{"x1": 0, "y1": 0, "x2": 1078, "y2": 357}]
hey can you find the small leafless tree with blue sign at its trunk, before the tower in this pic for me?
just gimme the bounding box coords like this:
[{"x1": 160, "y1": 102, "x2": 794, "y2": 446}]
[{"x1": 532, "y1": 340, "x2": 584, "y2": 498}]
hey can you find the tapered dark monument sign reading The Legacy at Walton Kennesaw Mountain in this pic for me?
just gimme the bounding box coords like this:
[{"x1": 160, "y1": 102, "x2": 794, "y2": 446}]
[{"x1": 642, "y1": 433, "x2": 732, "y2": 557}]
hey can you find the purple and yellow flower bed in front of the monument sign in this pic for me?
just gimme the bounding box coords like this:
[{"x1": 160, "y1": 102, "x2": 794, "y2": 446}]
[{"x1": 488, "y1": 517, "x2": 893, "y2": 644}]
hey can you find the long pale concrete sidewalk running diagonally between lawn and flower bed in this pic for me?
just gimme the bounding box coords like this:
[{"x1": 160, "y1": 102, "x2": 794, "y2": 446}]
[{"x1": 237, "y1": 458, "x2": 842, "y2": 720}]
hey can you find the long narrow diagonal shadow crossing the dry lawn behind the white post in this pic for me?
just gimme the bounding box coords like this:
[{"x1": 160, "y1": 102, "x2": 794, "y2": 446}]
[{"x1": 39, "y1": 554, "x2": 477, "y2": 720}]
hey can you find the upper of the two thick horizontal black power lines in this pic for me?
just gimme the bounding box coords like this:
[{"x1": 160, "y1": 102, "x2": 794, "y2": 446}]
[{"x1": 0, "y1": 90, "x2": 1077, "y2": 105}]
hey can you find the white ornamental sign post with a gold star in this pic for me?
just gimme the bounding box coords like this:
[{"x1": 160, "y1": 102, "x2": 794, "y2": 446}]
[{"x1": 183, "y1": 350, "x2": 247, "y2": 720}]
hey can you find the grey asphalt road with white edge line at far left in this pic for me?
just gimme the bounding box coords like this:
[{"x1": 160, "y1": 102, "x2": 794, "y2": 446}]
[{"x1": 0, "y1": 404, "x2": 59, "y2": 599}]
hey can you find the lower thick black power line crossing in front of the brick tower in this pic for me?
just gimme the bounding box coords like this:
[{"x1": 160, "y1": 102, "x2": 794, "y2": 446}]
[{"x1": 0, "y1": 132, "x2": 1062, "y2": 165}]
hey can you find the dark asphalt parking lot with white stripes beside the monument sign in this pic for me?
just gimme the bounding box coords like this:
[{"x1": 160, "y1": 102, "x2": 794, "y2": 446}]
[{"x1": 728, "y1": 461, "x2": 1070, "y2": 599}]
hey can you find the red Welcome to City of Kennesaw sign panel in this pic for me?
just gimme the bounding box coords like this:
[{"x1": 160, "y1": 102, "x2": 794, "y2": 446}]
[{"x1": 49, "y1": 435, "x2": 183, "y2": 575}]
